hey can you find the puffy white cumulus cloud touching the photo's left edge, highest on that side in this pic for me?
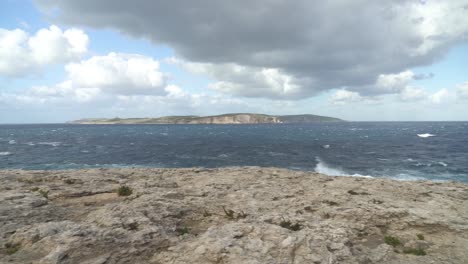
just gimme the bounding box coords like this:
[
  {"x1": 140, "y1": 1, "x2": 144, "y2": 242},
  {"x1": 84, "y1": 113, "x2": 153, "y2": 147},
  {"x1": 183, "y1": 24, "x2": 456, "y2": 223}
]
[{"x1": 0, "y1": 26, "x2": 89, "y2": 77}]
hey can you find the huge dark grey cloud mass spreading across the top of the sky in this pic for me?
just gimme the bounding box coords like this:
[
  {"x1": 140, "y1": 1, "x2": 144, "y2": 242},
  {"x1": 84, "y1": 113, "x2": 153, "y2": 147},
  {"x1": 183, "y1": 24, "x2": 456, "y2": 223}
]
[{"x1": 36, "y1": 0, "x2": 468, "y2": 99}]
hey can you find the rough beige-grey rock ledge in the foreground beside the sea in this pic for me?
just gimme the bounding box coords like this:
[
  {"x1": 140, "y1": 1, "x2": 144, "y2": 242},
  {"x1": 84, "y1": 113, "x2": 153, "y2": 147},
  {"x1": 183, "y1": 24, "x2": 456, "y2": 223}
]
[{"x1": 0, "y1": 167, "x2": 468, "y2": 264}]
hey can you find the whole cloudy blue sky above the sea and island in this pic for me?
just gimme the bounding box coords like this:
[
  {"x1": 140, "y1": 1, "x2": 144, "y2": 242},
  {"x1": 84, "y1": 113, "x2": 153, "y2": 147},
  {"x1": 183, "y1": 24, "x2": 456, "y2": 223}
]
[{"x1": 0, "y1": 0, "x2": 468, "y2": 123}]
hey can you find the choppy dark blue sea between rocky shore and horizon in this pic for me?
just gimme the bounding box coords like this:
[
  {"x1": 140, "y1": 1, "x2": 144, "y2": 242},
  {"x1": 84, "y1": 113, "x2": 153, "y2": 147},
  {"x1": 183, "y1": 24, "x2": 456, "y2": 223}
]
[{"x1": 0, "y1": 122, "x2": 468, "y2": 182}]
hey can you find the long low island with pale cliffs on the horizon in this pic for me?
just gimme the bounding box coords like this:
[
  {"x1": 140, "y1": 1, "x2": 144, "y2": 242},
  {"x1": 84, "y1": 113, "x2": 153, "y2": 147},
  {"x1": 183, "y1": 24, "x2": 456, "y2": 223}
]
[{"x1": 69, "y1": 113, "x2": 344, "y2": 124}]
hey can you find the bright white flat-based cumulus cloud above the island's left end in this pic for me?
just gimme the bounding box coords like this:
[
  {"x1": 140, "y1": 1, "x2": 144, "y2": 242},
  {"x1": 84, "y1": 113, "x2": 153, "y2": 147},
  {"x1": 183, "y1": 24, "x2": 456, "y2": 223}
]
[{"x1": 3, "y1": 53, "x2": 168, "y2": 104}]
